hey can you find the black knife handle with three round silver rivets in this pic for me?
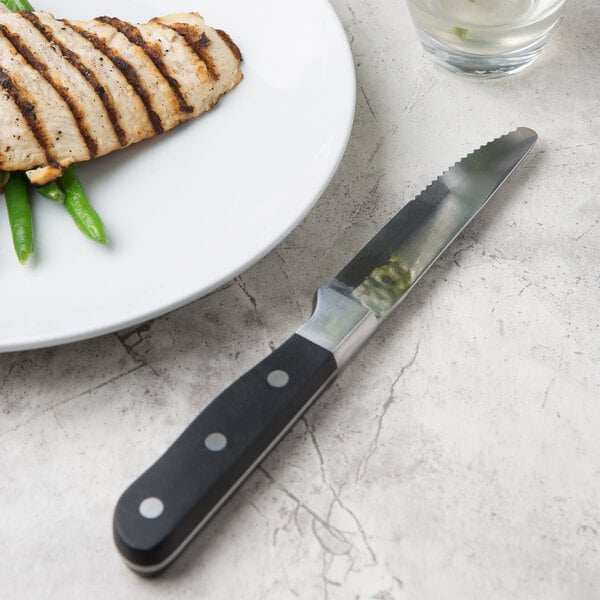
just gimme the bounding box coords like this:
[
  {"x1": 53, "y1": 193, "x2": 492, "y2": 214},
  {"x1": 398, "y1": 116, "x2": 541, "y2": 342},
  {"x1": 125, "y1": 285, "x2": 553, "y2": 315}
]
[{"x1": 113, "y1": 334, "x2": 337, "y2": 575}]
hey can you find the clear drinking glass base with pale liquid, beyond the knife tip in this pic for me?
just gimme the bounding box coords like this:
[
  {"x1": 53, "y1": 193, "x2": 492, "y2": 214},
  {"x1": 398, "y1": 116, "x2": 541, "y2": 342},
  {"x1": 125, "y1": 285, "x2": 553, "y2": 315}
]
[{"x1": 408, "y1": 0, "x2": 566, "y2": 77}]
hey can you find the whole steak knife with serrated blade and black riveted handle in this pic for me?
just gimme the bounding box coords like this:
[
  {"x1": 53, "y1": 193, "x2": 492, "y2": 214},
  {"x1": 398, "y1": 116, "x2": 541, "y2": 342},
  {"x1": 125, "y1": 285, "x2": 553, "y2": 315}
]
[{"x1": 113, "y1": 127, "x2": 537, "y2": 575}]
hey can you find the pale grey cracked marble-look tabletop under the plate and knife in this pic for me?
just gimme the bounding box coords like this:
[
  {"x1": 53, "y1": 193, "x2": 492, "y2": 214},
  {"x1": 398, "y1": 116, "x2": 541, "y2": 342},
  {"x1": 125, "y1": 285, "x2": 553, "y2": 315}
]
[{"x1": 0, "y1": 0, "x2": 600, "y2": 600}]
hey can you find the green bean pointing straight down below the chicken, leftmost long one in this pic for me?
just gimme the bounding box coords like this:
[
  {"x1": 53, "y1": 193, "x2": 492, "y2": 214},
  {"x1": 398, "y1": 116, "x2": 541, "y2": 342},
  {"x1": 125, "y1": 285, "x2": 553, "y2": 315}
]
[{"x1": 4, "y1": 172, "x2": 33, "y2": 265}]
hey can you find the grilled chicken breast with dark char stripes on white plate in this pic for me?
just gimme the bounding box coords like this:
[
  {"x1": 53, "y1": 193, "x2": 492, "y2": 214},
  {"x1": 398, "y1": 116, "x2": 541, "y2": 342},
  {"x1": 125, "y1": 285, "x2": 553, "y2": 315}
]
[{"x1": 0, "y1": 11, "x2": 242, "y2": 185}]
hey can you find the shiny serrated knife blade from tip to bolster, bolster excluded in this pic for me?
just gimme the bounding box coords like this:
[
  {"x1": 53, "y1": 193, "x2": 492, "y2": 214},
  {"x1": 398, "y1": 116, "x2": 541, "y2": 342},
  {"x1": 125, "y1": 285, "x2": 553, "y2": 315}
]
[{"x1": 329, "y1": 128, "x2": 537, "y2": 318}]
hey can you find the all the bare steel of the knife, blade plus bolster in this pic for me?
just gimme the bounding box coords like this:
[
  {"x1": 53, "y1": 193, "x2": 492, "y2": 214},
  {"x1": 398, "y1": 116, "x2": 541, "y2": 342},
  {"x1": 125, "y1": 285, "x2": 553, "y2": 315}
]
[{"x1": 297, "y1": 127, "x2": 537, "y2": 366}]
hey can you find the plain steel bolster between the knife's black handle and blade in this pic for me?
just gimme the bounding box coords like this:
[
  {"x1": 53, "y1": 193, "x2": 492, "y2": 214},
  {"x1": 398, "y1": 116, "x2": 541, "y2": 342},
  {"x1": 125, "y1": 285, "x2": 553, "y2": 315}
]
[{"x1": 296, "y1": 286, "x2": 379, "y2": 369}]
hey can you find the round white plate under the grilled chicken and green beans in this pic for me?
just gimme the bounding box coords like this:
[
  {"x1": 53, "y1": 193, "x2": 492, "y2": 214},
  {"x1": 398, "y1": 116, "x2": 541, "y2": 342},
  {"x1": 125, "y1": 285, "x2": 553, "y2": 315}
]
[{"x1": 0, "y1": 0, "x2": 355, "y2": 351}]
